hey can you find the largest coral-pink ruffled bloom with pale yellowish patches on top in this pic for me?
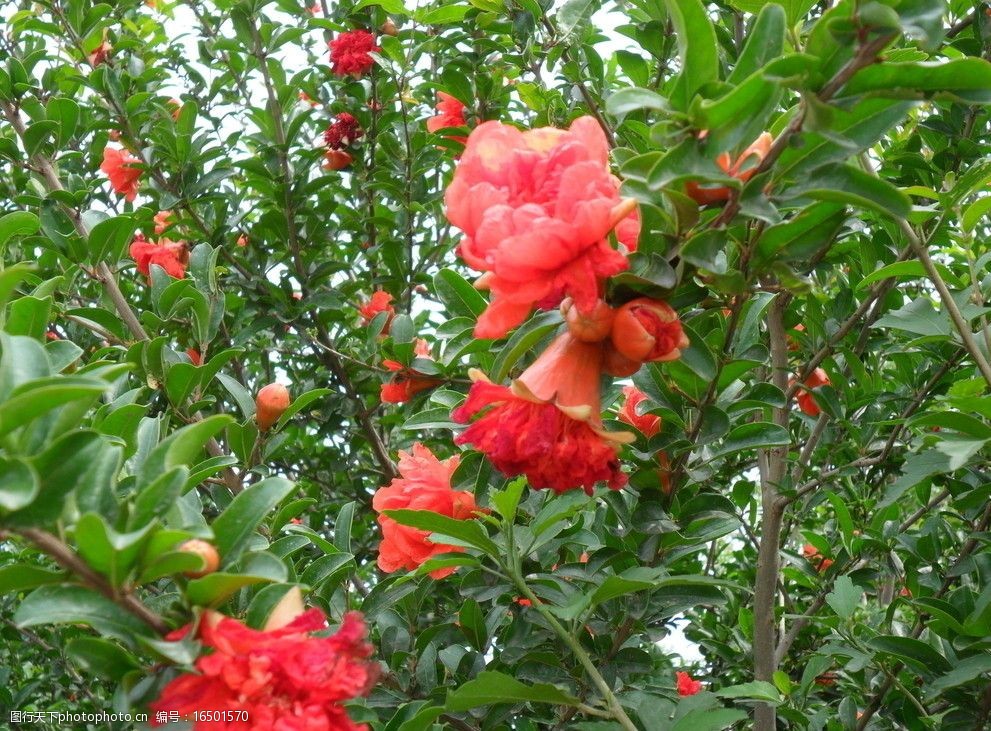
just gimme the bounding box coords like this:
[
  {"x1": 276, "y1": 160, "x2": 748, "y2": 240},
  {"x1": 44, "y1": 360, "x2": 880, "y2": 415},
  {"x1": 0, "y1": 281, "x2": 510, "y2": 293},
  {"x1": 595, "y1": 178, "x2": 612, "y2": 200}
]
[{"x1": 444, "y1": 117, "x2": 639, "y2": 338}]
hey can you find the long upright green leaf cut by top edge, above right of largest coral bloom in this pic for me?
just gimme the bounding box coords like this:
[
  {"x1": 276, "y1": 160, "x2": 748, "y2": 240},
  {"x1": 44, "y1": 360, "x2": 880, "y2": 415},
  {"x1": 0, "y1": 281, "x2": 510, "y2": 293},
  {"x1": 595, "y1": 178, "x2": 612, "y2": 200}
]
[{"x1": 664, "y1": 0, "x2": 719, "y2": 111}]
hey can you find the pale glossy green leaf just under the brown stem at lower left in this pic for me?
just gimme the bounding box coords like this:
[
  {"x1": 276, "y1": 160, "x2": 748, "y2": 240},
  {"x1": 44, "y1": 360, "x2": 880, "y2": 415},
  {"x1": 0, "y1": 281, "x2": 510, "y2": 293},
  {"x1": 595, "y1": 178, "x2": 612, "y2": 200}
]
[{"x1": 14, "y1": 584, "x2": 150, "y2": 645}]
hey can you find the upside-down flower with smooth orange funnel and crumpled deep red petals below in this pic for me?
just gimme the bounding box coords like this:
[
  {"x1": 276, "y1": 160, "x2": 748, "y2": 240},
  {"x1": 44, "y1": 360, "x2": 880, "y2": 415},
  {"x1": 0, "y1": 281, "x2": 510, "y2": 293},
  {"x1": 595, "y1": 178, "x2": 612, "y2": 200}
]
[{"x1": 451, "y1": 333, "x2": 633, "y2": 494}]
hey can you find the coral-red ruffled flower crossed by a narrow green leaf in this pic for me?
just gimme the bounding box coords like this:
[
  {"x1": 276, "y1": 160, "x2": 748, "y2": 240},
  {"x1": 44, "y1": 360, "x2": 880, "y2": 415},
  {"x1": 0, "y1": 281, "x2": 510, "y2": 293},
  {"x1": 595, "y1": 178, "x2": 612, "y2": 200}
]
[{"x1": 372, "y1": 442, "x2": 477, "y2": 579}]
